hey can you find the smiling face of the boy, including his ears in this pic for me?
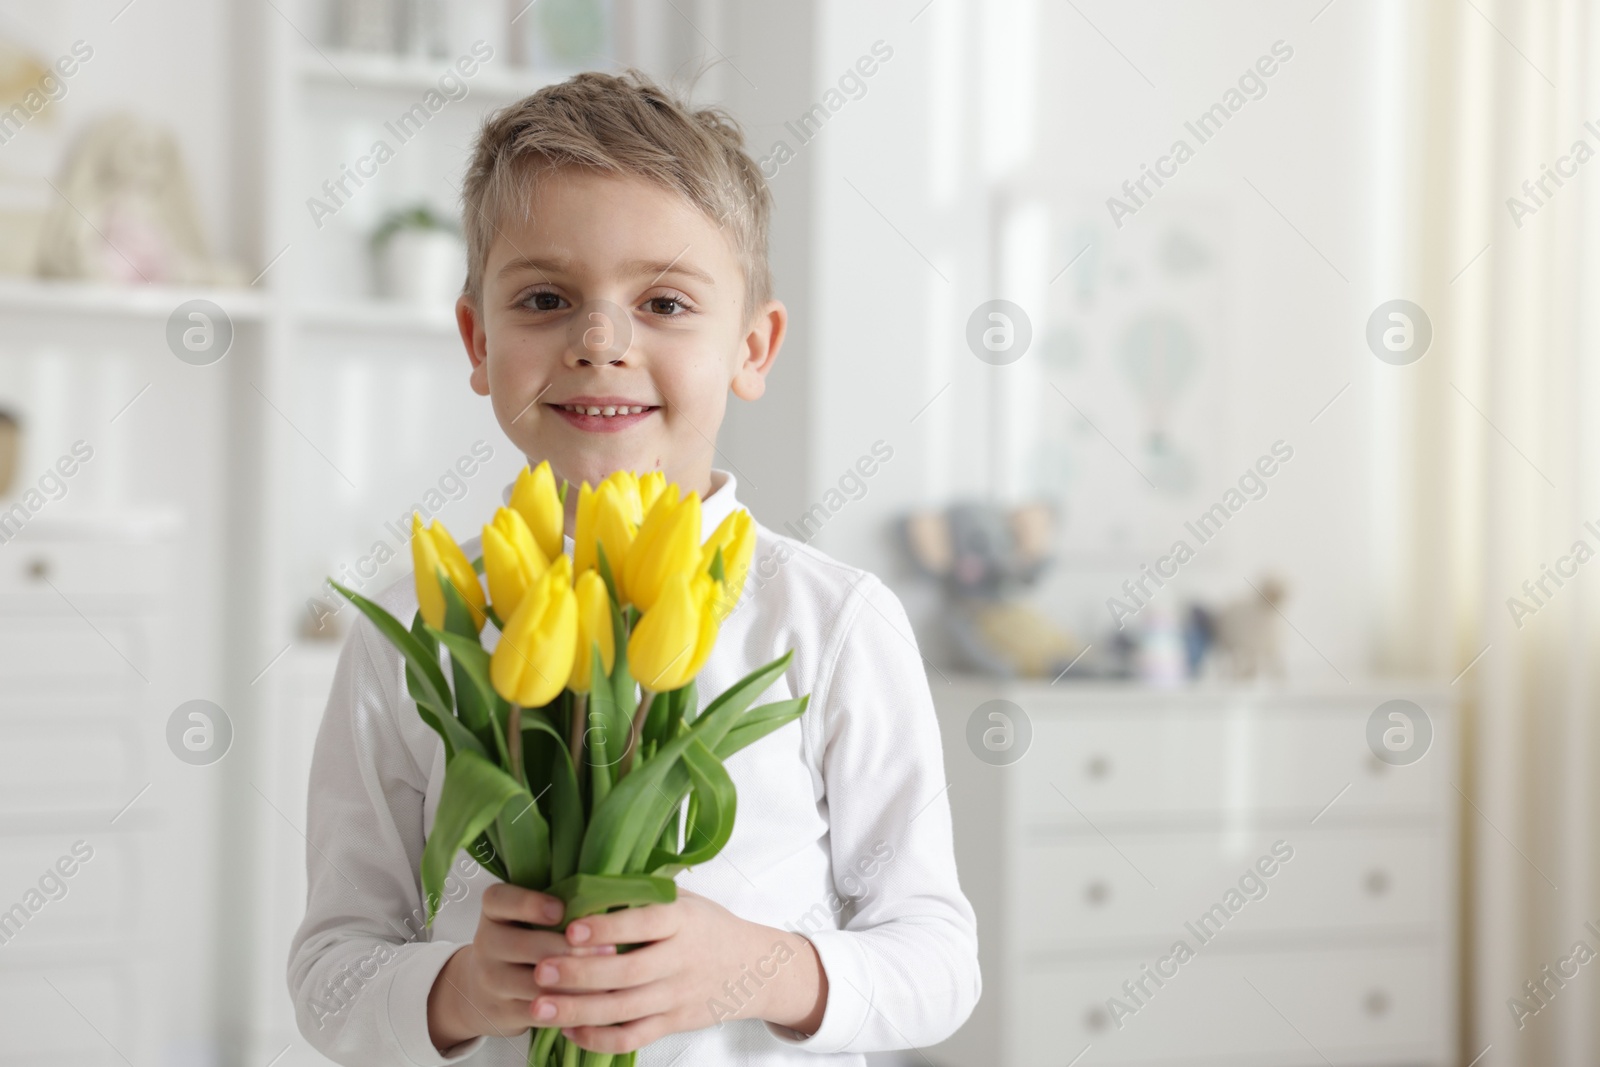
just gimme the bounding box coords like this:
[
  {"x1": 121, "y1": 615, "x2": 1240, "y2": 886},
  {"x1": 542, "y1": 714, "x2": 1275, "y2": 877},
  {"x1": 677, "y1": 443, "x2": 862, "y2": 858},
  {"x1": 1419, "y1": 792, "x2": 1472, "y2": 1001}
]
[{"x1": 456, "y1": 168, "x2": 784, "y2": 514}]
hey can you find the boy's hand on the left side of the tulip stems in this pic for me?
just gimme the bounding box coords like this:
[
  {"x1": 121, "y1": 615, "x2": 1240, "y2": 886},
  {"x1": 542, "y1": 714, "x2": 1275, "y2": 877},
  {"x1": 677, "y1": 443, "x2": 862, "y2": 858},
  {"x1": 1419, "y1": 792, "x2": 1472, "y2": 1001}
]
[{"x1": 427, "y1": 881, "x2": 616, "y2": 1053}]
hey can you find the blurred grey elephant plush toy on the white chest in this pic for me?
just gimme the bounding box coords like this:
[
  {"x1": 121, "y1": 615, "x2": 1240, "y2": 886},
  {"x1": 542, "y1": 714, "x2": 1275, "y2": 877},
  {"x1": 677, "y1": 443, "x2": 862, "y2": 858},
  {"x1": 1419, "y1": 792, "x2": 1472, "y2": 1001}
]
[{"x1": 899, "y1": 502, "x2": 1078, "y2": 678}]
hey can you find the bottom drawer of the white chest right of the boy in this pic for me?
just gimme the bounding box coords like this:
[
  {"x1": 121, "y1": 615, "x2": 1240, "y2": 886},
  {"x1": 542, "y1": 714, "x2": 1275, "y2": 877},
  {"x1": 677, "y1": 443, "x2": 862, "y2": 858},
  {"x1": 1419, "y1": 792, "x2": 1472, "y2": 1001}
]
[{"x1": 1003, "y1": 942, "x2": 1451, "y2": 1067}]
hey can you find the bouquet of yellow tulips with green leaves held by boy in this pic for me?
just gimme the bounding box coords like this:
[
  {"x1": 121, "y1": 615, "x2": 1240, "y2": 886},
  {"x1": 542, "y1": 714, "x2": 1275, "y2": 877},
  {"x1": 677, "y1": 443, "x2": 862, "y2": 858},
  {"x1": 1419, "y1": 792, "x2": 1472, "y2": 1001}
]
[{"x1": 330, "y1": 462, "x2": 810, "y2": 1067}]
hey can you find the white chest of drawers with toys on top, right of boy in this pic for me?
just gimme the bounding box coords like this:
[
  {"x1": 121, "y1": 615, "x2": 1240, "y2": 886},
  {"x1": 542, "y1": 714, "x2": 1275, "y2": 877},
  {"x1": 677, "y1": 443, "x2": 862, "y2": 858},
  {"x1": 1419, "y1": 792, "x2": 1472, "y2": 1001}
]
[{"x1": 926, "y1": 678, "x2": 1459, "y2": 1067}]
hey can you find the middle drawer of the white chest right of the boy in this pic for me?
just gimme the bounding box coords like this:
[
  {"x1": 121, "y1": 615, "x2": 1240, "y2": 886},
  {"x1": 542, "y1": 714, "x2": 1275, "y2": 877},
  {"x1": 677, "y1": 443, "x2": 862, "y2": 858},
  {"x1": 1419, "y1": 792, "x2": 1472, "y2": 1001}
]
[{"x1": 1014, "y1": 829, "x2": 1450, "y2": 953}]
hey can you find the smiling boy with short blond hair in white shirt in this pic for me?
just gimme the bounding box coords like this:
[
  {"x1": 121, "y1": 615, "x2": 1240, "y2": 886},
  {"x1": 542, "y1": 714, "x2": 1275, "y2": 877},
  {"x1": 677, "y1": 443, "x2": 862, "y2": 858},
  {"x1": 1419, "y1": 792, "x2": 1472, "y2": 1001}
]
[{"x1": 288, "y1": 70, "x2": 981, "y2": 1067}]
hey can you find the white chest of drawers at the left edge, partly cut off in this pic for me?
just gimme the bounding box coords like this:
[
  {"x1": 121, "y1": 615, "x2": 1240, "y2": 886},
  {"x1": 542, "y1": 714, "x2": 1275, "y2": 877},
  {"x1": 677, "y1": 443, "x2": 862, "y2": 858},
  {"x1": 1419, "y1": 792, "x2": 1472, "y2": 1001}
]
[{"x1": 0, "y1": 512, "x2": 180, "y2": 1067}]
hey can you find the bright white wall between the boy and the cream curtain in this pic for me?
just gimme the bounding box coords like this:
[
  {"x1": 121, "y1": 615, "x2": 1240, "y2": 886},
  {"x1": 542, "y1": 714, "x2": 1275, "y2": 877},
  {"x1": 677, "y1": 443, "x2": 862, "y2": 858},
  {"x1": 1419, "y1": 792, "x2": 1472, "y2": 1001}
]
[{"x1": 763, "y1": 2, "x2": 1376, "y2": 680}]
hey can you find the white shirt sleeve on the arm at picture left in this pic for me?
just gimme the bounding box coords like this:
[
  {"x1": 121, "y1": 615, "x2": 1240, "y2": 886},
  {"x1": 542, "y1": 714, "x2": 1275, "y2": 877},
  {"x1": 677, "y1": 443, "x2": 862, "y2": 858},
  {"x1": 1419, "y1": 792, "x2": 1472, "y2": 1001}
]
[{"x1": 288, "y1": 617, "x2": 486, "y2": 1067}]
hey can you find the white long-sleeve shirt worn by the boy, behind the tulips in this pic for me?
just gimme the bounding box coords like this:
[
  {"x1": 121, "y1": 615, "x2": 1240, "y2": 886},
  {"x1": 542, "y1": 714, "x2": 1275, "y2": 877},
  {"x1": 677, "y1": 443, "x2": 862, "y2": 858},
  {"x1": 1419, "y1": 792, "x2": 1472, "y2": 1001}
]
[{"x1": 288, "y1": 469, "x2": 981, "y2": 1067}]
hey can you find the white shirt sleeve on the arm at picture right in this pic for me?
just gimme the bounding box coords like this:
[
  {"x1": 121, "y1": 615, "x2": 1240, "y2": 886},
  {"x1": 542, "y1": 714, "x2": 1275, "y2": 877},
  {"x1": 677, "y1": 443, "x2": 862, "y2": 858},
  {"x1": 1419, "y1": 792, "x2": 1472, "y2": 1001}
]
[{"x1": 766, "y1": 573, "x2": 982, "y2": 1053}]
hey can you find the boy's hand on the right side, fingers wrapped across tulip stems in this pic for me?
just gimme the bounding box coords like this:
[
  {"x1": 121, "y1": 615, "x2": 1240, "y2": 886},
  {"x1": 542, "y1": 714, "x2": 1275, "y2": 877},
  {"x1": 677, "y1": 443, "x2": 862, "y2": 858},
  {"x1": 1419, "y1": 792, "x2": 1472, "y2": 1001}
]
[{"x1": 531, "y1": 889, "x2": 827, "y2": 1053}]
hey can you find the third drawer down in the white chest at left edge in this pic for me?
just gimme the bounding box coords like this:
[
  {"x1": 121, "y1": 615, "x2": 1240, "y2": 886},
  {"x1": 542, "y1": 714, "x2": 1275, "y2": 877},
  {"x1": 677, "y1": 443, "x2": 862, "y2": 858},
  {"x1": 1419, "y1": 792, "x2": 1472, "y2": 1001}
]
[{"x1": 0, "y1": 712, "x2": 150, "y2": 819}]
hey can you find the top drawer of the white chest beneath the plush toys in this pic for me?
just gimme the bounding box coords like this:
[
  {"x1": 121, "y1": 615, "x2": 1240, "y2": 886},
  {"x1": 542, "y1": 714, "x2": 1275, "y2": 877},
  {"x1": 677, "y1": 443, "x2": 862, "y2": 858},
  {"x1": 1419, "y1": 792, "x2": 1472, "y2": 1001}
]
[{"x1": 1016, "y1": 705, "x2": 1448, "y2": 825}]
